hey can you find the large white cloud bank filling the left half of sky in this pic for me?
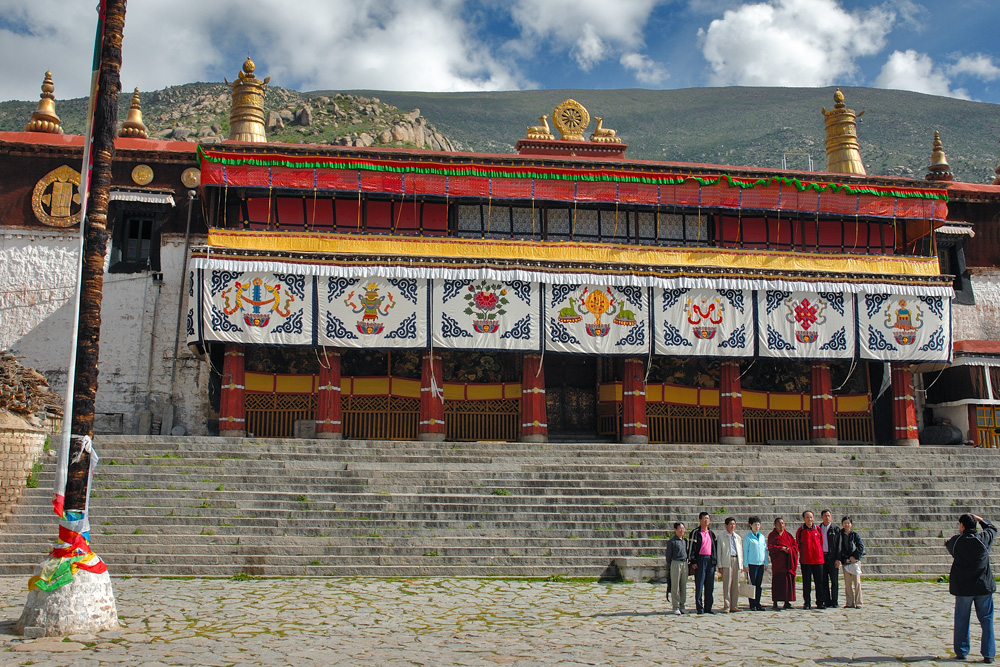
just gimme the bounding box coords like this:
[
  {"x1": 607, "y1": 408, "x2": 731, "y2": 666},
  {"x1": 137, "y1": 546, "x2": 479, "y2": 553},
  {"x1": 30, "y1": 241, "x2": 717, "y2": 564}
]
[{"x1": 0, "y1": 0, "x2": 532, "y2": 99}]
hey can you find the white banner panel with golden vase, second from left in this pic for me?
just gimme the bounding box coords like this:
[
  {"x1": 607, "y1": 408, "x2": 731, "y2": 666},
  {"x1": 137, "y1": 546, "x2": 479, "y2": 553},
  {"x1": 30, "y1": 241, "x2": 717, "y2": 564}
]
[{"x1": 317, "y1": 275, "x2": 429, "y2": 348}]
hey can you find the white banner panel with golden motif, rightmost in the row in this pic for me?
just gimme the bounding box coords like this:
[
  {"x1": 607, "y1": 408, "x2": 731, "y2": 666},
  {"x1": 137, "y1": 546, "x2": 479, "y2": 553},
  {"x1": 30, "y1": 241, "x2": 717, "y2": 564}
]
[{"x1": 858, "y1": 294, "x2": 952, "y2": 361}]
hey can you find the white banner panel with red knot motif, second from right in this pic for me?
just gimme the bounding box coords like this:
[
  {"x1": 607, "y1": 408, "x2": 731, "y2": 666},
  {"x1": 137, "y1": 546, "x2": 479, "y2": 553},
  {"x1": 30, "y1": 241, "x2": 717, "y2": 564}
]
[{"x1": 757, "y1": 290, "x2": 855, "y2": 359}]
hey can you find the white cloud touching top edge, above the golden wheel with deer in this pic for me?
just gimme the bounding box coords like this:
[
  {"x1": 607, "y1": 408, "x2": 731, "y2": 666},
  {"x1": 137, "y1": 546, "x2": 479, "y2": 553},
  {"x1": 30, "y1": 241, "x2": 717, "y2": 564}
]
[{"x1": 510, "y1": 0, "x2": 664, "y2": 72}]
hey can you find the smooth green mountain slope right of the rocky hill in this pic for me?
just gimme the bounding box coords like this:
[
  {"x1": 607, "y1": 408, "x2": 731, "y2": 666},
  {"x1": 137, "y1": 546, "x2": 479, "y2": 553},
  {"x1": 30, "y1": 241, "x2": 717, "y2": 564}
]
[{"x1": 336, "y1": 87, "x2": 1000, "y2": 183}]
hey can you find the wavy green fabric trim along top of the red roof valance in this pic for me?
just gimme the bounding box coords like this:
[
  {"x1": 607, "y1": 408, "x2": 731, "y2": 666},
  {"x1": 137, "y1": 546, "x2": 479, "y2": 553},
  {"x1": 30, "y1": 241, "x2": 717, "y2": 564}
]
[{"x1": 198, "y1": 146, "x2": 948, "y2": 201}]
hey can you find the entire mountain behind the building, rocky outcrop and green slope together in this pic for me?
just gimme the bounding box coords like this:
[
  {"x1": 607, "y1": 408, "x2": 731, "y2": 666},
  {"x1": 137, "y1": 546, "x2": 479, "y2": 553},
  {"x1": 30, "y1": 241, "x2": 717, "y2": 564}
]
[{"x1": 0, "y1": 83, "x2": 1000, "y2": 183}]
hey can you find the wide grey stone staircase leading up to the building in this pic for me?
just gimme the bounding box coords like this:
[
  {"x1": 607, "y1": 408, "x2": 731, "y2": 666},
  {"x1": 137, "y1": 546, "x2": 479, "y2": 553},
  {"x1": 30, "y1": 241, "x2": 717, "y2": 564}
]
[{"x1": 0, "y1": 436, "x2": 1000, "y2": 578}]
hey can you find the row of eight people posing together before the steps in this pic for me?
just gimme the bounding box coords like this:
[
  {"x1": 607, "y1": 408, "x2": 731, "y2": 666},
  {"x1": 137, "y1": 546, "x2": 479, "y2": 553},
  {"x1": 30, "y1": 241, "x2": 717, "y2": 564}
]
[{"x1": 667, "y1": 510, "x2": 865, "y2": 615}]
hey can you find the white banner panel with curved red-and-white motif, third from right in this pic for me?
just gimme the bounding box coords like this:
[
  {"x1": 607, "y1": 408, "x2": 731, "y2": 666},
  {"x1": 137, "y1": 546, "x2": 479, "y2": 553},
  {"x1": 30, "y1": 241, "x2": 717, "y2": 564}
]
[{"x1": 653, "y1": 287, "x2": 754, "y2": 357}]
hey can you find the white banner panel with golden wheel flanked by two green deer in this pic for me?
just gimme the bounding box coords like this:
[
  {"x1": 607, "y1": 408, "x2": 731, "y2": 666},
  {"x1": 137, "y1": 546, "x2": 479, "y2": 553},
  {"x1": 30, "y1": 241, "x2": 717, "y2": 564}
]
[{"x1": 543, "y1": 284, "x2": 652, "y2": 355}]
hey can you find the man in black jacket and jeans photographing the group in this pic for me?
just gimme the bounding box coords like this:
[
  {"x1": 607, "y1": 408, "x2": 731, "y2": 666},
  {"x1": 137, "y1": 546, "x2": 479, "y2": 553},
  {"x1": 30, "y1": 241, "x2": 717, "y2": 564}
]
[{"x1": 945, "y1": 514, "x2": 997, "y2": 663}]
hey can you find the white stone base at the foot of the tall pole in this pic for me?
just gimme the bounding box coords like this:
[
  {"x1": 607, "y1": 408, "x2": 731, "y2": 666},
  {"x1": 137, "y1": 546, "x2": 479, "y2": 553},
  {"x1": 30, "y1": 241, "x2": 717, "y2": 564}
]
[{"x1": 14, "y1": 569, "x2": 119, "y2": 638}]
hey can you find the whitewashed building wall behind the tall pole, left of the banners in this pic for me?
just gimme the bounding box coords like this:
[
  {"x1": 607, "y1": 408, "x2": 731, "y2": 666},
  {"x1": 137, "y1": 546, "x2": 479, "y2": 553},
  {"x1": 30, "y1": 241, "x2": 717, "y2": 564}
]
[{"x1": 0, "y1": 229, "x2": 216, "y2": 434}]
